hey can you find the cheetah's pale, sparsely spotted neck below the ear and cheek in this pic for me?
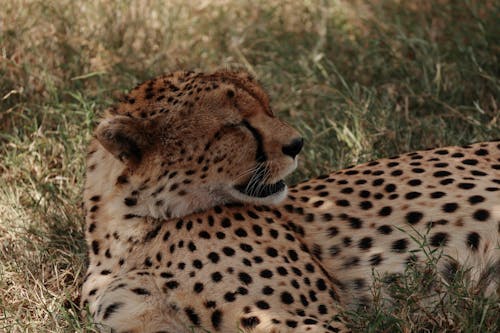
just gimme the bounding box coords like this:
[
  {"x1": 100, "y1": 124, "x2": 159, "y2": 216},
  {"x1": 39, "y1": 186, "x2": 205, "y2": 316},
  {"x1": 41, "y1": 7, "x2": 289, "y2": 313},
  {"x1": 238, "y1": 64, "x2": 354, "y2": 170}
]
[{"x1": 84, "y1": 141, "x2": 223, "y2": 250}]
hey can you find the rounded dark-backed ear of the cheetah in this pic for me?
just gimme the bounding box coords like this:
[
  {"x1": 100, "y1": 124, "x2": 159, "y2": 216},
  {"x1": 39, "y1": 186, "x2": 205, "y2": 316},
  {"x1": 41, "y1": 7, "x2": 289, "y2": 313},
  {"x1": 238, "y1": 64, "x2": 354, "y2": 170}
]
[{"x1": 95, "y1": 116, "x2": 148, "y2": 167}]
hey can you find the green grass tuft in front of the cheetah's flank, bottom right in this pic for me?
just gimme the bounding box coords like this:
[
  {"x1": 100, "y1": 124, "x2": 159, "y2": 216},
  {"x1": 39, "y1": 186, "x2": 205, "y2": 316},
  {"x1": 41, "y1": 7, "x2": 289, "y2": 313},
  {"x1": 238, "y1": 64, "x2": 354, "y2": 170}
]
[{"x1": 346, "y1": 229, "x2": 500, "y2": 333}]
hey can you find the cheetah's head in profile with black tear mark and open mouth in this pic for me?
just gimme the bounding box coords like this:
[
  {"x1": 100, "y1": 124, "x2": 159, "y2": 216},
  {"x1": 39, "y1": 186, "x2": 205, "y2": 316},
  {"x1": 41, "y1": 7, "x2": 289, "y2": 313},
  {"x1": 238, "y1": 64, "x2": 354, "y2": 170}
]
[{"x1": 95, "y1": 71, "x2": 303, "y2": 217}]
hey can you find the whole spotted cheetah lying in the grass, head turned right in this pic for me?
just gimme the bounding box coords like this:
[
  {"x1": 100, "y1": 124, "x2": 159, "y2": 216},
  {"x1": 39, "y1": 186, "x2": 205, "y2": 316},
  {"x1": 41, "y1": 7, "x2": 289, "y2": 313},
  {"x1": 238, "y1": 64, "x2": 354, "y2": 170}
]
[{"x1": 82, "y1": 71, "x2": 500, "y2": 332}]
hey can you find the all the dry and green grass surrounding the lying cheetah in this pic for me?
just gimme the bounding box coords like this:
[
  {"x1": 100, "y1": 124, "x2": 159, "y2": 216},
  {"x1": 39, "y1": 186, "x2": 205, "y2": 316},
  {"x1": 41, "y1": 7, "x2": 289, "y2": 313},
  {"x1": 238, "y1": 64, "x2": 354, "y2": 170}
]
[{"x1": 0, "y1": 0, "x2": 500, "y2": 332}]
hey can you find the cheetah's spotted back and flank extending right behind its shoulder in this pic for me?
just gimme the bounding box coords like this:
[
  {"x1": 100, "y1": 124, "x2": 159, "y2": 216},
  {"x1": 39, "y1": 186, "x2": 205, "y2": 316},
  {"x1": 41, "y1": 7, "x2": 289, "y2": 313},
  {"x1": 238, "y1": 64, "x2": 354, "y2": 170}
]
[{"x1": 282, "y1": 140, "x2": 500, "y2": 306}]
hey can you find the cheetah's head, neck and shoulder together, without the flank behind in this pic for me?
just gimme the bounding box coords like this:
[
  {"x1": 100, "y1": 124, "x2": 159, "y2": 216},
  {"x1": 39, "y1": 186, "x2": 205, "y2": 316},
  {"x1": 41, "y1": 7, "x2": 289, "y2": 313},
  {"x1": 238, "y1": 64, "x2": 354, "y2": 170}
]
[{"x1": 82, "y1": 71, "x2": 347, "y2": 333}]
